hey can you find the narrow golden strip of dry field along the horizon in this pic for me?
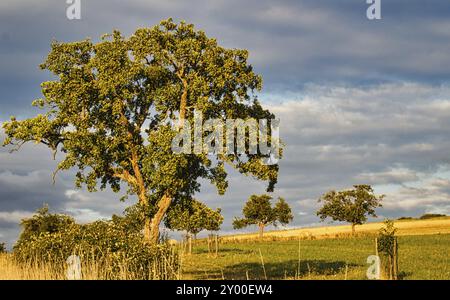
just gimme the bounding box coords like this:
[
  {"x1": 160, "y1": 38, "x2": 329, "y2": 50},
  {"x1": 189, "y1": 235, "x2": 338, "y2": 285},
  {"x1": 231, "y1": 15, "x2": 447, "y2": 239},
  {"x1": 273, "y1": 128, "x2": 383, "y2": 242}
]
[{"x1": 221, "y1": 217, "x2": 450, "y2": 242}]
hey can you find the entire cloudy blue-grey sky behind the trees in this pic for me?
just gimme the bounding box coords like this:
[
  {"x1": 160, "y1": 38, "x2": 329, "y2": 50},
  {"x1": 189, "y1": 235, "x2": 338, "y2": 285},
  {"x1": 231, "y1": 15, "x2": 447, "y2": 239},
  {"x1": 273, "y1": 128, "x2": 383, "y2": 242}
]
[{"x1": 0, "y1": 0, "x2": 450, "y2": 247}]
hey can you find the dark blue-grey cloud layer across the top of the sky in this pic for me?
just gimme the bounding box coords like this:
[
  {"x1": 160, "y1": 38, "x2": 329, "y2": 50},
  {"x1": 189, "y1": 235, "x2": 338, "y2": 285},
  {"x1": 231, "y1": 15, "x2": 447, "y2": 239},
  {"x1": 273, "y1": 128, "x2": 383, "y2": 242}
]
[{"x1": 0, "y1": 0, "x2": 450, "y2": 118}]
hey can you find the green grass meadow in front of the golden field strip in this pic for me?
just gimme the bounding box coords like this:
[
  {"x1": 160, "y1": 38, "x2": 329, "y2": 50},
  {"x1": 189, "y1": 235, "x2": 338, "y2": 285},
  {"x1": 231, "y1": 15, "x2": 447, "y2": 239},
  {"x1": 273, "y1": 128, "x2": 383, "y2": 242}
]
[{"x1": 183, "y1": 234, "x2": 450, "y2": 279}]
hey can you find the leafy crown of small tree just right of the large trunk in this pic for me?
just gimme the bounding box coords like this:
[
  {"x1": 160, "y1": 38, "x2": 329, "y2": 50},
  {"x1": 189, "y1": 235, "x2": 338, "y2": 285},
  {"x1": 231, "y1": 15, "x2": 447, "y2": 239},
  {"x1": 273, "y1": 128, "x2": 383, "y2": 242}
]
[{"x1": 165, "y1": 200, "x2": 223, "y2": 235}]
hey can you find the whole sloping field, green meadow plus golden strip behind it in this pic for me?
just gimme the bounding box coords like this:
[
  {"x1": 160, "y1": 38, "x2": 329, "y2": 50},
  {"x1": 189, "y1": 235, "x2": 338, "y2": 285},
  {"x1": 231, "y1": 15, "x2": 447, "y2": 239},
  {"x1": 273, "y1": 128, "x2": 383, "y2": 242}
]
[{"x1": 183, "y1": 218, "x2": 450, "y2": 279}]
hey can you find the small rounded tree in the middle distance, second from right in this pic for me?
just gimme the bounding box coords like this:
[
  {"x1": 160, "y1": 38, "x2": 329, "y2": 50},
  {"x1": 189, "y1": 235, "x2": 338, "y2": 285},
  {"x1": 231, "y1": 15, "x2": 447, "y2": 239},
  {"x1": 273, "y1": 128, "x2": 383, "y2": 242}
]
[{"x1": 233, "y1": 194, "x2": 294, "y2": 237}]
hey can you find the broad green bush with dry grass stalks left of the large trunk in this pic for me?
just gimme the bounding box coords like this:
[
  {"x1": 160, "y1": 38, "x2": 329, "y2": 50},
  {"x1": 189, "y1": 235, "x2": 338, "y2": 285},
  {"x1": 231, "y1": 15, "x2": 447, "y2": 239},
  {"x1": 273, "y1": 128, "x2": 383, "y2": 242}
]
[{"x1": 14, "y1": 206, "x2": 179, "y2": 279}]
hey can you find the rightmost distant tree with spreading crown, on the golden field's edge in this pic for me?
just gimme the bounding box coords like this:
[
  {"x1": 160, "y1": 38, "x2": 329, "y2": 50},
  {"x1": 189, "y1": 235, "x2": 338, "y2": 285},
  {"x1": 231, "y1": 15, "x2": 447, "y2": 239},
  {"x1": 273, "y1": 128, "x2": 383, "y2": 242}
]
[{"x1": 317, "y1": 185, "x2": 384, "y2": 234}]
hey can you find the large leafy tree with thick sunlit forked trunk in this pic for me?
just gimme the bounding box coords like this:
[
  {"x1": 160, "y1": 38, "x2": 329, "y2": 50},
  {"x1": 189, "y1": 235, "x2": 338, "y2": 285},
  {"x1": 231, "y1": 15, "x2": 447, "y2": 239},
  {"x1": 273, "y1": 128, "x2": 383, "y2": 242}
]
[{"x1": 3, "y1": 19, "x2": 278, "y2": 243}]
